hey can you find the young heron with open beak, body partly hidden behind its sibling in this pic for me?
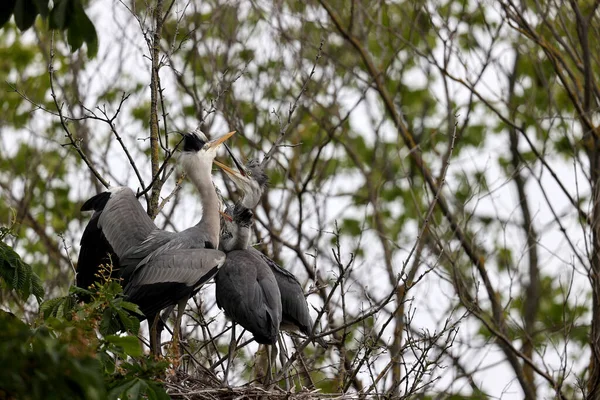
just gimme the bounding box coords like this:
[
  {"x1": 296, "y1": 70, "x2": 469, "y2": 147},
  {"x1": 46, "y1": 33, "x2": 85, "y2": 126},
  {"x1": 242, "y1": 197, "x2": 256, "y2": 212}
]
[{"x1": 215, "y1": 155, "x2": 327, "y2": 348}]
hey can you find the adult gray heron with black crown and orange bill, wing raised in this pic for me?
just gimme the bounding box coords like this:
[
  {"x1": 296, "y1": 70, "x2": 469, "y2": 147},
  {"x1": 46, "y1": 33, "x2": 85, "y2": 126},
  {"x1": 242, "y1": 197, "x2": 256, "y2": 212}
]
[{"x1": 78, "y1": 132, "x2": 234, "y2": 354}]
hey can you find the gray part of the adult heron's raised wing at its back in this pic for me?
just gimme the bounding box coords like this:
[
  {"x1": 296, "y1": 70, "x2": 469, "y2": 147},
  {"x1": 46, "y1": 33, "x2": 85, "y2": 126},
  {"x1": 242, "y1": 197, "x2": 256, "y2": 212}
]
[{"x1": 98, "y1": 186, "x2": 158, "y2": 259}]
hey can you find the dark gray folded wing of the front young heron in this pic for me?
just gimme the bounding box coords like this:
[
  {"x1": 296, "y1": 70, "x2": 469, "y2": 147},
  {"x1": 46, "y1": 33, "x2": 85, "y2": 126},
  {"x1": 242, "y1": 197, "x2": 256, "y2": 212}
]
[{"x1": 215, "y1": 250, "x2": 281, "y2": 344}]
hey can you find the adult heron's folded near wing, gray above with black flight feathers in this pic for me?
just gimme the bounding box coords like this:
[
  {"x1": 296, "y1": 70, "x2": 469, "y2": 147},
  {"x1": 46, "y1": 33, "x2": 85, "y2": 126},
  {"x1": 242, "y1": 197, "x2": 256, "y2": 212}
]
[{"x1": 124, "y1": 249, "x2": 225, "y2": 315}]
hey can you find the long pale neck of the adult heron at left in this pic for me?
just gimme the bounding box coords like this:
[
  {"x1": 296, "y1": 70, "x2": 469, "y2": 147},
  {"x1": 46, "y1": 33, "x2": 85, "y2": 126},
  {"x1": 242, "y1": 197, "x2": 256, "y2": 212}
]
[{"x1": 185, "y1": 158, "x2": 220, "y2": 248}]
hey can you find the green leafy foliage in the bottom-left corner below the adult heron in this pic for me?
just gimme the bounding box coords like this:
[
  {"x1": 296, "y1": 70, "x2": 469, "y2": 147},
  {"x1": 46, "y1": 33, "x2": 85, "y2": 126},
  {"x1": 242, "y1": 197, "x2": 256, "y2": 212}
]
[{"x1": 0, "y1": 264, "x2": 169, "y2": 399}]
